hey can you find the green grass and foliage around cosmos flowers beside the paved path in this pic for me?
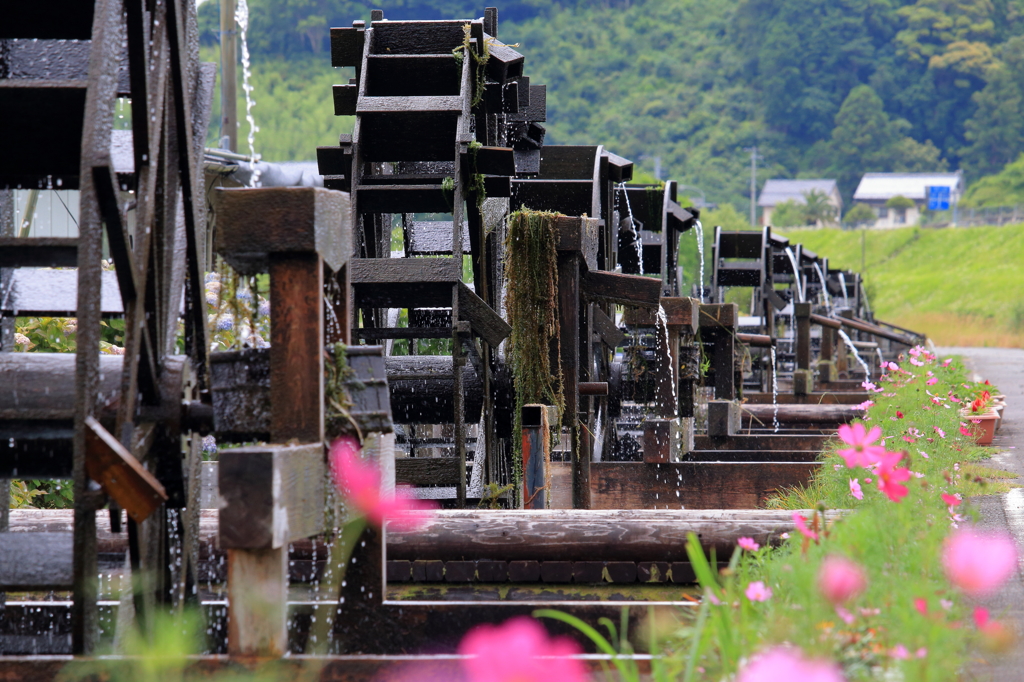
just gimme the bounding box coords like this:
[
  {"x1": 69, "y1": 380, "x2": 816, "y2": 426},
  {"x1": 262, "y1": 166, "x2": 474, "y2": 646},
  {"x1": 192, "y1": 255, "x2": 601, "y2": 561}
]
[{"x1": 647, "y1": 348, "x2": 1010, "y2": 682}]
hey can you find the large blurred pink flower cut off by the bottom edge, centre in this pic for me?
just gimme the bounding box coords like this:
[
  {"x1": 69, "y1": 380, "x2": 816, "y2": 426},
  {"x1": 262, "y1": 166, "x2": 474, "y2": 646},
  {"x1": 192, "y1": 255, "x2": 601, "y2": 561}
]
[{"x1": 459, "y1": 615, "x2": 587, "y2": 682}]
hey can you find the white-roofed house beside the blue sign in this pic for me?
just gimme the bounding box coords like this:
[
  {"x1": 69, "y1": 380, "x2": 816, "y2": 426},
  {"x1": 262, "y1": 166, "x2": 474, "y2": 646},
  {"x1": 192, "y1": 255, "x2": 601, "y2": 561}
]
[{"x1": 853, "y1": 171, "x2": 964, "y2": 227}]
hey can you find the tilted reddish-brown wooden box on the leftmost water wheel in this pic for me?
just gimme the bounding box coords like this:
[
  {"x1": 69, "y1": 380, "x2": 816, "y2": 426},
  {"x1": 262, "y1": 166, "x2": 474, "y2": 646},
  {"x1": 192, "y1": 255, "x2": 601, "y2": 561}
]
[{"x1": 85, "y1": 417, "x2": 167, "y2": 523}]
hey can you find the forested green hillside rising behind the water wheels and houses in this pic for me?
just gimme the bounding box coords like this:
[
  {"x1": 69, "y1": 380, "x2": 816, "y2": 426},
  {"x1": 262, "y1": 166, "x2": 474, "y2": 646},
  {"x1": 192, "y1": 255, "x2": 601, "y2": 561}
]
[{"x1": 193, "y1": 0, "x2": 1024, "y2": 210}]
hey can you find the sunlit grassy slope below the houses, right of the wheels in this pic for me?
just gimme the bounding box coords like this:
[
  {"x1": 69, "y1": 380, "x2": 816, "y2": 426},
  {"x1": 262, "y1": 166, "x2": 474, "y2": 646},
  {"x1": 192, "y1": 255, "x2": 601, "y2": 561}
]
[{"x1": 770, "y1": 225, "x2": 1024, "y2": 347}]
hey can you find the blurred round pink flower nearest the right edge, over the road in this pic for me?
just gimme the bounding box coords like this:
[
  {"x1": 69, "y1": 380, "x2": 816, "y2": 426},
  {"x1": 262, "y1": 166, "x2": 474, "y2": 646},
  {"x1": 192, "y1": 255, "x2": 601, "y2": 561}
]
[{"x1": 942, "y1": 527, "x2": 1017, "y2": 597}]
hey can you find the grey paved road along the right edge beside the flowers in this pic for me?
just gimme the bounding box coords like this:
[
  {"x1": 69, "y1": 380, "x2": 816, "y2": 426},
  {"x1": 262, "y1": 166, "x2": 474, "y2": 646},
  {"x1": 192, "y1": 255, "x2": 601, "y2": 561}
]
[{"x1": 938, "y1": 348, "x2": 1024, "y2": 682}]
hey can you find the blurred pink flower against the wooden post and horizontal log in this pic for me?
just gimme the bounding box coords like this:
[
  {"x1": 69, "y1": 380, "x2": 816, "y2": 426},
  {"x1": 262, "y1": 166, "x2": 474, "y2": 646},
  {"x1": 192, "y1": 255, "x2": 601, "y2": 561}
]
[{"x1": 331, "y1": 435, "x2": 434, "y2": 528}]
